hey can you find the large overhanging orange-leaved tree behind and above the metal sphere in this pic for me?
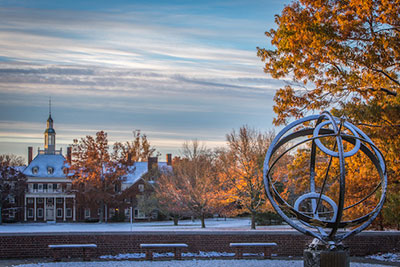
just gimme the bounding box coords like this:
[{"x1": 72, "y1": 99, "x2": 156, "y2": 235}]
[{"x1": 258, "y1": 0, "x2": 400, "y2": 230}]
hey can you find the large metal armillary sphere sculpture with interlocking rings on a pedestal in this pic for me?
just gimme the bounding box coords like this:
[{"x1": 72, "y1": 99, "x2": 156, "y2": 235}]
[{"x1": 264, "y1": 111, "x2": 387, "y2": 249}]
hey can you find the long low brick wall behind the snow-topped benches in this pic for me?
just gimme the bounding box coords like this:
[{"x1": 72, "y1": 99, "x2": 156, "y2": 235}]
[{"x1": 0, "y1": 231, "x2": 400, "y2": 258}]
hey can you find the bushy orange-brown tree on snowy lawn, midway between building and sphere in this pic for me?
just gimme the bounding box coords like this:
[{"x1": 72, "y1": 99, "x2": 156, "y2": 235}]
[{"x1": 156, "y1": 141, "x2": 223, "y2": 228}]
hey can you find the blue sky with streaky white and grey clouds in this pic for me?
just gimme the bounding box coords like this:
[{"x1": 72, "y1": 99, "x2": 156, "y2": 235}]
[{"x1": 0, "y1": 0, "x2": 290, "y2": 164}]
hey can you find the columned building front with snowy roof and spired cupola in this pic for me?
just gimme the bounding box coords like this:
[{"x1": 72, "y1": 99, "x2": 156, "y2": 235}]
[{"x1": 23, "y1": 113, "x2": 76, "y2": 222}]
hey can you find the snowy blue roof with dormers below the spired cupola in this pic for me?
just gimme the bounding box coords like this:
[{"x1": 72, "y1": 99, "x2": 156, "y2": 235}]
[{"x1": 23, "y1": 154, "x2": 69, "y2": 177}]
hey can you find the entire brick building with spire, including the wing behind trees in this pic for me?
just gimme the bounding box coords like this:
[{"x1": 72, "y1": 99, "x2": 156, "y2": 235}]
[{"x1": 10, "y1": 113, "x2": 172, "y2": 222}]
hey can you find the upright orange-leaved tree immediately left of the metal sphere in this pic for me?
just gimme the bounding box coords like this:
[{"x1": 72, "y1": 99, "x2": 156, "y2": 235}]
[{"x1": 218, "y1": 126, "x2": 274, "y2": 229}]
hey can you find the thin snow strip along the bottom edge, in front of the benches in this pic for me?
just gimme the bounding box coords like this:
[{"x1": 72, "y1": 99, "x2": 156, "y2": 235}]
[{"x1": 13, "y1": 260, "x2": 394, "y2": 267}]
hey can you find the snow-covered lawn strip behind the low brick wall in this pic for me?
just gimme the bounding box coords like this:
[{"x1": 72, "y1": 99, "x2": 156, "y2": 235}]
[{"x1": 0, "y1": 218, "x2": 292, "y2": 233}]
